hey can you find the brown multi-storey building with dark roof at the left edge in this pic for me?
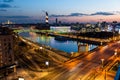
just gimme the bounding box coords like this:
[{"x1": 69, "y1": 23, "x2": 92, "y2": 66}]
[{"x1": 0, "y1": 27, "x2": 14, "y2": 68}]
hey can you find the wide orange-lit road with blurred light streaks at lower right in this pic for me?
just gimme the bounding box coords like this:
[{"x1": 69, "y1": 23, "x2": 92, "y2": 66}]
[{"x1": 40, "y1": 41, "x2": 120, "y2": 80}]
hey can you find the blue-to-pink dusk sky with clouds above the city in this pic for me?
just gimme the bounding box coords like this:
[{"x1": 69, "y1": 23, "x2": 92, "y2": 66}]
[{"x1": 0, "y1": 0, "x2": 120, "y2": 23}]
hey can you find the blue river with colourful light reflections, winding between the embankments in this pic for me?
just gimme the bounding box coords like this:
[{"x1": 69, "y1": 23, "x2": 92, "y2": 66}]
[{"x1": 19, "y1": 32, "x2": 97, "y2": 53}]
